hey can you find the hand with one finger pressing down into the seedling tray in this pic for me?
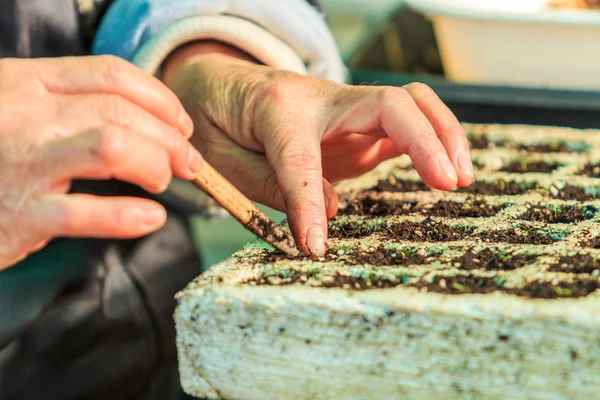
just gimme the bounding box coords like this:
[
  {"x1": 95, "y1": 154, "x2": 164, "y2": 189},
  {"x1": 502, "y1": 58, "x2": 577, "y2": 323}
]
[{"x1": 164, "y1": 43, "x2": 473, "y2": 256}]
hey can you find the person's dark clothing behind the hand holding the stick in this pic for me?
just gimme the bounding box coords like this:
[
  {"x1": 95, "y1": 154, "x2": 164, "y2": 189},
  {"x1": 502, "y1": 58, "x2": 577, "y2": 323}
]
[{"x1": 0, "y1": 0, "x2": 322, "y2": 400}]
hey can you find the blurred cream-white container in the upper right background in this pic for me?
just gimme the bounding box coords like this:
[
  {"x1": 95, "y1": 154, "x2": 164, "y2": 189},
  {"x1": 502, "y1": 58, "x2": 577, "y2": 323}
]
[{"x1": 406, "y1": 0, "x2": 600, "y2": 90}]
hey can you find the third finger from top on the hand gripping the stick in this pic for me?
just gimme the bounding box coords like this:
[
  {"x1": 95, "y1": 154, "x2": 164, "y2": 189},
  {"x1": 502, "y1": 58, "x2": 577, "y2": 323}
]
[{"x1": 35, "y1": 125, "x2": 202, "y2": 192}]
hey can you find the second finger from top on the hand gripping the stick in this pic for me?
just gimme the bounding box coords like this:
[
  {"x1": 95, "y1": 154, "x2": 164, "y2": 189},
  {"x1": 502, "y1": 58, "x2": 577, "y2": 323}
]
[{"x1": 53, "y1": 94, "x2": 200, "y2": 179}]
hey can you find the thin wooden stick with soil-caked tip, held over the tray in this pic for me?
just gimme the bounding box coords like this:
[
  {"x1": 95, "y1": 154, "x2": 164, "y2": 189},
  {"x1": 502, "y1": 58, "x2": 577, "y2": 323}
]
[{"x1": 194, "y1": 163, "x2": 299, "y2": 257}]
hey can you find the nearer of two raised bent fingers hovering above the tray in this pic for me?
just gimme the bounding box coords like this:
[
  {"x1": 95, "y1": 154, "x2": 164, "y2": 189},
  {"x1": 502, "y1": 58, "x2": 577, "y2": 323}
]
[{"x1": 325, "y1": 86, "x2": 468, "y2": 190}]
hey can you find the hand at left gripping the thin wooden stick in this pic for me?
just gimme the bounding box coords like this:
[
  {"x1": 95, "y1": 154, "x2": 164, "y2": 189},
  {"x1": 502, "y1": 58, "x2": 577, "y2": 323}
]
[{"x1": 0, "y1": 57, "x2": 203, "y2": 270}]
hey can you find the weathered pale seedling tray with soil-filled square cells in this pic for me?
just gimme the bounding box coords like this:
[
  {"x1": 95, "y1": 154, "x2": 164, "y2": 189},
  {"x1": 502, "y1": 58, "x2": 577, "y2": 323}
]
[{"x1": 175, "y1": 124, "x2": 600, "y2": 400}]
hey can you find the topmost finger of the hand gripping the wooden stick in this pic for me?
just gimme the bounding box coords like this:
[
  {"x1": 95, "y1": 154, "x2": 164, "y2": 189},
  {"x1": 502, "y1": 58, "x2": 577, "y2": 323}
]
[{"x1": 33, "y1": 56, "x2": 193, "y2": 138}]
